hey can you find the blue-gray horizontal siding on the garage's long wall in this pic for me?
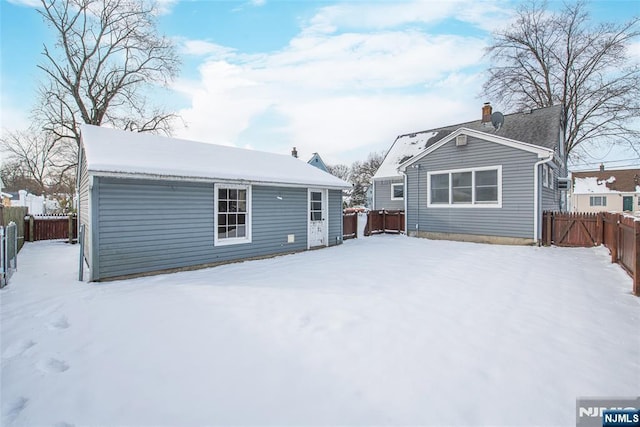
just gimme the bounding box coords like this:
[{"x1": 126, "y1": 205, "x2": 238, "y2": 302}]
[{"x1": 93, "y1": 178, "x2": 308, "y2": 280}]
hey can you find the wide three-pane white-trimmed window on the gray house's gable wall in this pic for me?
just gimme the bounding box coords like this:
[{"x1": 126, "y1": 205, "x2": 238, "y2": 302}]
[{"x1": 427, "y1": 166, "x2": 502, "y2": 207}]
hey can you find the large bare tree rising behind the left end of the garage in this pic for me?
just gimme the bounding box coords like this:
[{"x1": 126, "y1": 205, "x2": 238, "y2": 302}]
[{"x1": 37, "y1": 0, "x2": 179, "y2": 147}]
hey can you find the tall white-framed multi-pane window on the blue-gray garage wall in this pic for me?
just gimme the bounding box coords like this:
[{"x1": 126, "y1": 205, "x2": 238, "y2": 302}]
[{"x1": 214, "y1": 184, "x2": 251, "y2": 245}]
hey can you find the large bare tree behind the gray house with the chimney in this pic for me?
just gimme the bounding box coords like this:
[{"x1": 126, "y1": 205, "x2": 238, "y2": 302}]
[{"x1": 483, "y1": 0, "x2": 640, "y2": 166}]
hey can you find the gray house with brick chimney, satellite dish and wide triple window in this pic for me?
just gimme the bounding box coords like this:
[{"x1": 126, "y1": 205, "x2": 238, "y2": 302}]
[{"x1": 373, "y1": 104, "x2": 565, "y2": 244}]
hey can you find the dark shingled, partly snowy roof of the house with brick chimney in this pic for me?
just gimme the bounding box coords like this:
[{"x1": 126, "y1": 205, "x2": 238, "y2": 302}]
[{"x1": 373, "y1": 105, "x2": 562, "y2": 179}]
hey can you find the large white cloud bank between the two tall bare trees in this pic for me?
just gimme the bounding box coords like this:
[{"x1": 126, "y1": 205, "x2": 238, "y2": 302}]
[{"x1": 176, "y1": 2, "x2": 500, "y2": 163}]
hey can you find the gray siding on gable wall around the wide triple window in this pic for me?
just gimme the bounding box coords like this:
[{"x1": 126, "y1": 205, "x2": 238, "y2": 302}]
[{"x1": 406, "y1": 138, "x2": 538, "y2": 238}]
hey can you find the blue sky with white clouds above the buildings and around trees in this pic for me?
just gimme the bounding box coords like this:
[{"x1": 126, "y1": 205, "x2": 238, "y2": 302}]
[{"x1": 0, "y1": 0, "x2": 640, "y2": 167}]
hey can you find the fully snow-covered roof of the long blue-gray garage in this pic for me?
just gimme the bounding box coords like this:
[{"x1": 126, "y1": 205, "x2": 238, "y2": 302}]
[{"x1": 81, "y1": 125, "x2": 351, "y2": 189}]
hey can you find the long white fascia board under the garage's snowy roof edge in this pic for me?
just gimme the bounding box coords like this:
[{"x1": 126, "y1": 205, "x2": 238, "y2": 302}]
[{"x1": 89, "y1": 170, "x2": 352, "y2": 190}]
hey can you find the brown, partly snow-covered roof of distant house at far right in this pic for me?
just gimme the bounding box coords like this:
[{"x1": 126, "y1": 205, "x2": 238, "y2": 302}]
[{"x1": 571, "y1": 169, "x2": 640, "y2": 194}]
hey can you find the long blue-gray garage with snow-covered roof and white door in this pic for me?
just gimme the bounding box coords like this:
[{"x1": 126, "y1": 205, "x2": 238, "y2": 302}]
[{"x1": 77, "y1": 125, "x2": 350, "y2": 281}]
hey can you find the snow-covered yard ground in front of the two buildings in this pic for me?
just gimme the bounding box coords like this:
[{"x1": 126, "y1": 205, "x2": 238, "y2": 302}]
[{"x1": 0, "y1": 236, "x2": 640, "y2": 426}]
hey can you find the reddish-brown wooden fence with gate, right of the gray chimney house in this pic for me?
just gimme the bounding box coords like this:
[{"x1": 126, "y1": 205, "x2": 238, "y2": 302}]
[{"x1": 542, "y1": 212, "x2": 640, "y2": 296}]
